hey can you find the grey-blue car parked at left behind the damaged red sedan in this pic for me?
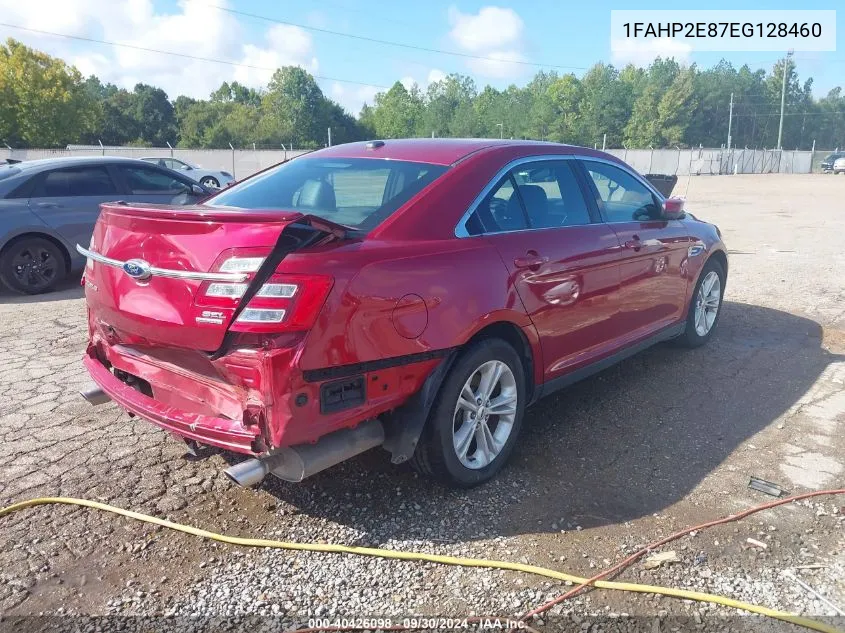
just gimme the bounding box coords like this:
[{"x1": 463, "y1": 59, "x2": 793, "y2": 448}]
[{"x1": 0, "y1": 156, "x2": 212, "y2": 294}]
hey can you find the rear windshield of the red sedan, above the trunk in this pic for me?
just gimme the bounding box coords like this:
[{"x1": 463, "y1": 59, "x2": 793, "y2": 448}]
[{"x1": 208, "y1": 158, "x2": 447, "y2": 230}]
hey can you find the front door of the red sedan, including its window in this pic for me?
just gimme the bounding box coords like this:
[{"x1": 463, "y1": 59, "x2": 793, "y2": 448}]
[{"x1": 580, "y1": 158, "x2": 690, "y2": 342}]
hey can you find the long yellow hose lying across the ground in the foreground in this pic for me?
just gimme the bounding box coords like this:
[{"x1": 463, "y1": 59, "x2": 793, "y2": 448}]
[{"x1": 0, "y1": 497, "x2": 842, "y2": 633}]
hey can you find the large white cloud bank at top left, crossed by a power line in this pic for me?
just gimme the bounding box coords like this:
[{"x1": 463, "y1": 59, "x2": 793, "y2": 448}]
[{"x1": 0, "y1": 0, "x2": 318, "y2": 98}]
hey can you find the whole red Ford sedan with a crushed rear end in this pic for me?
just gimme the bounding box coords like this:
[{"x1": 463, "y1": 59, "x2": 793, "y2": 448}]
[{"x1": 77, "y1": 139, "x2": 728, "y2": 486}]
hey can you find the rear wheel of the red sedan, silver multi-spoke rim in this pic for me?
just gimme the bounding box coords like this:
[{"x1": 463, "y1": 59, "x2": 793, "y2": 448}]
[{"x1": 411, "y1": 339, "x2": 525, "y2": 488}]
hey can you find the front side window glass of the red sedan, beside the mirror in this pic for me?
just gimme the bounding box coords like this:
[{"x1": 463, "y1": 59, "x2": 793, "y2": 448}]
[{"x1": 583, "y1": 160, "x2": 661, "y2": 222}]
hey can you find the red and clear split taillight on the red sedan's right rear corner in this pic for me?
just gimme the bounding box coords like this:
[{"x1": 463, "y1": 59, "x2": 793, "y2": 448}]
[{"x1": 196, "y1": 249, "x2": 333, "y2": 332}]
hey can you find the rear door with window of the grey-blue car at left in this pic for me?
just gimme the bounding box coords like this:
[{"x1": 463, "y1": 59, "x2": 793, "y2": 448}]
[{"x1": 29, "y1": 165, "x2": 120, "y2": 252}]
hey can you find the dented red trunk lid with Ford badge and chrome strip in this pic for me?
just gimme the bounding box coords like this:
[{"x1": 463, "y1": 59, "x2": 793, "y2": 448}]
[{"x1": 83, "y1": 203, "x2": 320, "y2": 352}]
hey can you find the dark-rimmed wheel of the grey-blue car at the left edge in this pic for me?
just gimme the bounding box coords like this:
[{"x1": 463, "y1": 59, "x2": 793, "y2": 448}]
[{"x1": 0, "y1": 237, "x2": 67, "y2": 295}]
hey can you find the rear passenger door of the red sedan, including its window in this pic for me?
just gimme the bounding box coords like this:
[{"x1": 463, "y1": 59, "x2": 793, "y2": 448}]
[{"x1": 458, "y1": 157, "x2": 619, "y2": 381}]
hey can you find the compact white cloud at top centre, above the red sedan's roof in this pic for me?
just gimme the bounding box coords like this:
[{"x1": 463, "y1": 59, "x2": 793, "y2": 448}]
[{"x1": 449, "y1": 6, "x2": 525, "y2": 79}]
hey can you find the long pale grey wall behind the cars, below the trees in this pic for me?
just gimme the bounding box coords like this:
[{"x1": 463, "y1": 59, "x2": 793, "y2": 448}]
[{"x1": 0, "y1": 147, "x2": 816, "y2": 179}]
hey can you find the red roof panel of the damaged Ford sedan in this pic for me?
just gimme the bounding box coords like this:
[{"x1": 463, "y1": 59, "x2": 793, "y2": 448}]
[{"x1": 309, "y1": 138, "x2": 584, "y2": 165}]
